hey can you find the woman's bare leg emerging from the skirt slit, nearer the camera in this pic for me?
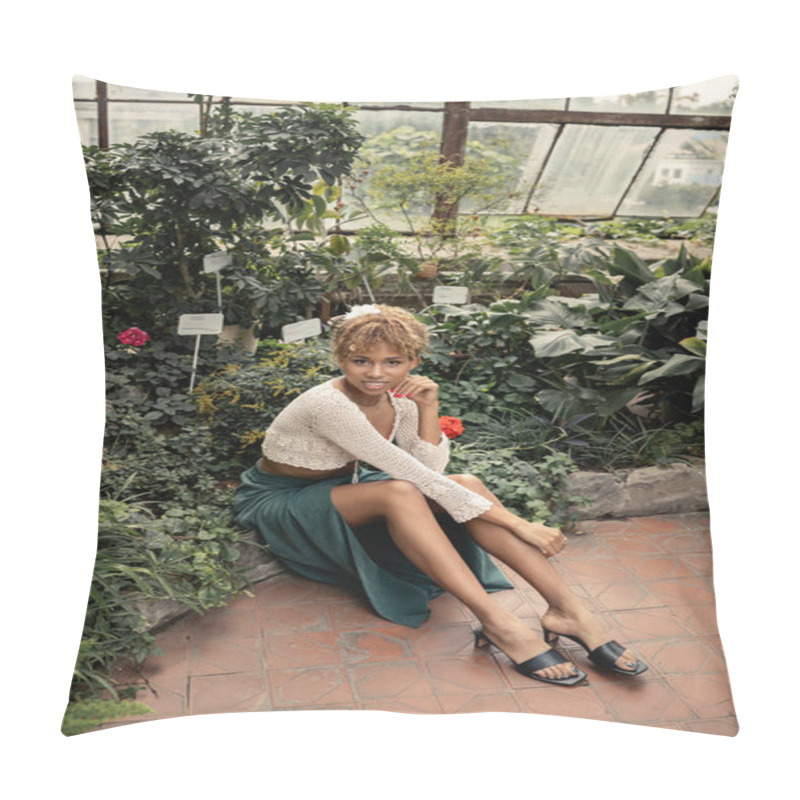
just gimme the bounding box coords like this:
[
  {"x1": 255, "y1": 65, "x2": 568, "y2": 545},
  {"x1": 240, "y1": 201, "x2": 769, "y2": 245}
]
[{"x1": 331, "y1": 480, "x2": 575, "y2": 679}]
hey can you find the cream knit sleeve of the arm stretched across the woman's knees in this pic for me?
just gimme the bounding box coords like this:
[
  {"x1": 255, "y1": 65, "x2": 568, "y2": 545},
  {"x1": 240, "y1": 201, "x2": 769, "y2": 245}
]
[{"x1": 313, "y1": 391, "x2": 492, "y2": 522}]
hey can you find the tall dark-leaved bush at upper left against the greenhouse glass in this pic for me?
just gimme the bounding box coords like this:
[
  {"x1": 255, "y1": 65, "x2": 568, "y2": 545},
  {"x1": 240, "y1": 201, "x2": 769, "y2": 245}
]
[{"x1": 85, "y1": 105, "x2": 363, "y2": 333}]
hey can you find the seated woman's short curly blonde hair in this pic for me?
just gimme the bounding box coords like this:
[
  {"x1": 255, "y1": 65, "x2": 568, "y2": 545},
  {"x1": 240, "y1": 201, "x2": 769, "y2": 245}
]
[{"x1": 333, "y1": 305, "x2": 428, "y2": 361}]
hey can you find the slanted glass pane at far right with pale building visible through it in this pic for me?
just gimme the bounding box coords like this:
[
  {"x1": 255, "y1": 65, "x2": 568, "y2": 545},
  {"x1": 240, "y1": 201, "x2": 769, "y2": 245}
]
[{"x1": 619, "y1": 130, "x2": 728, "y2": 217}]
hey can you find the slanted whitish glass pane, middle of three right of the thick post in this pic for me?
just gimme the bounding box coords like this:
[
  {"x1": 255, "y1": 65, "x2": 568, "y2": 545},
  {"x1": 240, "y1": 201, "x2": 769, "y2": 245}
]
[{"x1": 528, "y1": 125, "x2": 658, "y2": 216}]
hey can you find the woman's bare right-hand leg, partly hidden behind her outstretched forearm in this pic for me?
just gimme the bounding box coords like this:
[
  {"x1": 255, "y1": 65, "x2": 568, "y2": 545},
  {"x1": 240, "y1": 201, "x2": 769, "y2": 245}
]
[{"x1": 448, "y1": 475, "x2": 637, "y2": 670}]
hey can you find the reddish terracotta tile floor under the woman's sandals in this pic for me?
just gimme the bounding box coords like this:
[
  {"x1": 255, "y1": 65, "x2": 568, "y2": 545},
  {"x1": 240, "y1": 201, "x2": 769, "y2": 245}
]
[{"x1": 111, "y1": 513, "x2": 738, "y2": 736}]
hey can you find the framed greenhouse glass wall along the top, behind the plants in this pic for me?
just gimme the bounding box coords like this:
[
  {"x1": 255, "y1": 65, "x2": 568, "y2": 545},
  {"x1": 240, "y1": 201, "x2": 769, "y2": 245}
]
[{"x1": 74, "y1": 76, "x2": 737, "y2": 220}]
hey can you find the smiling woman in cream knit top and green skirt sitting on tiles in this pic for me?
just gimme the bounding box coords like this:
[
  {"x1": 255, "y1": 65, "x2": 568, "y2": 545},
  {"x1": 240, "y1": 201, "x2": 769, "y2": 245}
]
[{"x1": 235, "y1": 305, "x2": 647, "y2": 686}]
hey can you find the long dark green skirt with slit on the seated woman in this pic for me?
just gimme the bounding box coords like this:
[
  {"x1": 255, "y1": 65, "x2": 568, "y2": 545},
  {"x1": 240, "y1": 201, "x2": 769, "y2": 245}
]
[{"x1": 234, "y1": 465, "x2": 513, "y2": 628}]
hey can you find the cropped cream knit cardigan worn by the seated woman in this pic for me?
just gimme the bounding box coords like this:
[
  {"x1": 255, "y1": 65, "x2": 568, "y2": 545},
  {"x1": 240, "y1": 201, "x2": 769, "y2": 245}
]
[{"x1": 261, "y1": 378, "x2": 492, "y2": 522}]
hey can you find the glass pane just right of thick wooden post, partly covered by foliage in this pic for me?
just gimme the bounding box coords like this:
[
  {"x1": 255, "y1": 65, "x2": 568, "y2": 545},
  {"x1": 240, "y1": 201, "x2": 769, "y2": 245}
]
[{"x1": 461, "y1": 122, "x2": 558, "y2": 214}]
